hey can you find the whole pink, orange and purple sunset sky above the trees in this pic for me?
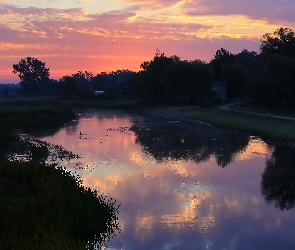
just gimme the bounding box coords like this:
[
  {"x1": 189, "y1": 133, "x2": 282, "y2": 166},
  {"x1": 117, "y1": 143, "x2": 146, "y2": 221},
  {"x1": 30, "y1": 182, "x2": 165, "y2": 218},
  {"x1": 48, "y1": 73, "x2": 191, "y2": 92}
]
[{"x1": 0, "y1": 0, "x2": 295, "y2": 83}]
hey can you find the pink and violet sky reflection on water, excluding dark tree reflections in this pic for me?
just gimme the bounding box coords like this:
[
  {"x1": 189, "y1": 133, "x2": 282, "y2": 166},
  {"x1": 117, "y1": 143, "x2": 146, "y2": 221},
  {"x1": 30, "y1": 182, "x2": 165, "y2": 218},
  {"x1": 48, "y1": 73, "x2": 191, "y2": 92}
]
[{"x1": 38, "y1": 113, "x2": 295, "y2": 249}]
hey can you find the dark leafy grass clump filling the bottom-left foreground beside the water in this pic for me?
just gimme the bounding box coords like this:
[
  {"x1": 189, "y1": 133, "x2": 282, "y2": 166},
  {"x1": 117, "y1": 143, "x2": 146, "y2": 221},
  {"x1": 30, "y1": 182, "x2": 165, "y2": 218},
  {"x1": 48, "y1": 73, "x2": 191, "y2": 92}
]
[{"x1": 0, "y1": 161, "x2": 117, "y2": 249}]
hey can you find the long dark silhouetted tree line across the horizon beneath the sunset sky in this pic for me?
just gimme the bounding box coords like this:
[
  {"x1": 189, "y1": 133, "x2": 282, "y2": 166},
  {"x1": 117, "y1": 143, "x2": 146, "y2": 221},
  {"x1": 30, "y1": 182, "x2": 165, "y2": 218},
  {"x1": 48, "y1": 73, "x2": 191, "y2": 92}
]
[{"x1": 6, "y1": 28, "x2": 295, "y2": 108}]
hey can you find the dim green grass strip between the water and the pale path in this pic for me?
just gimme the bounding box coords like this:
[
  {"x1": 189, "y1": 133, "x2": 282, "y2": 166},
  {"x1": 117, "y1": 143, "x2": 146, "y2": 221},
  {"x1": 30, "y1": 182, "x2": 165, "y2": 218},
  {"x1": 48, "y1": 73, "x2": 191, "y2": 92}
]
[{"x1": 148, "y1": 107, "x2": 295, "y2": 142}]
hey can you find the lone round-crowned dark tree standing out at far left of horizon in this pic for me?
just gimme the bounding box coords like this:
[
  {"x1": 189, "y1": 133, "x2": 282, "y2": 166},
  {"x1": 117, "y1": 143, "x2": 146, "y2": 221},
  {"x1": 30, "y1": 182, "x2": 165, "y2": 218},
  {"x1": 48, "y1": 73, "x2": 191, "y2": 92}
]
[{"x1": 12, "y1": 57, "x2": 50, "y2": 95}]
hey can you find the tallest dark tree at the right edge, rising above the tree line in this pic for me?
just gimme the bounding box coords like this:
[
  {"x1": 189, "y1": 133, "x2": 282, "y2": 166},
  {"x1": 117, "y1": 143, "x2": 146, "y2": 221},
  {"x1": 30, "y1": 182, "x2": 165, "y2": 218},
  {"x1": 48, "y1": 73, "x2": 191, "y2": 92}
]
[{"x1": 260, "y1": 28, "x2": 295, "y2": 108}]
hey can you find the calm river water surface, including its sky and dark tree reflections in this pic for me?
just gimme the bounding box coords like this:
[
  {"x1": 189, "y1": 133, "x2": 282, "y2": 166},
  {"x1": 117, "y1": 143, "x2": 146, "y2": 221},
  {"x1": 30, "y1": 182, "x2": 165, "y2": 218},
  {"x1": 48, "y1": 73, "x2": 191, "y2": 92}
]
[{"x1": 37, "y1": 112, "x2": 295, "y2": 250}]
